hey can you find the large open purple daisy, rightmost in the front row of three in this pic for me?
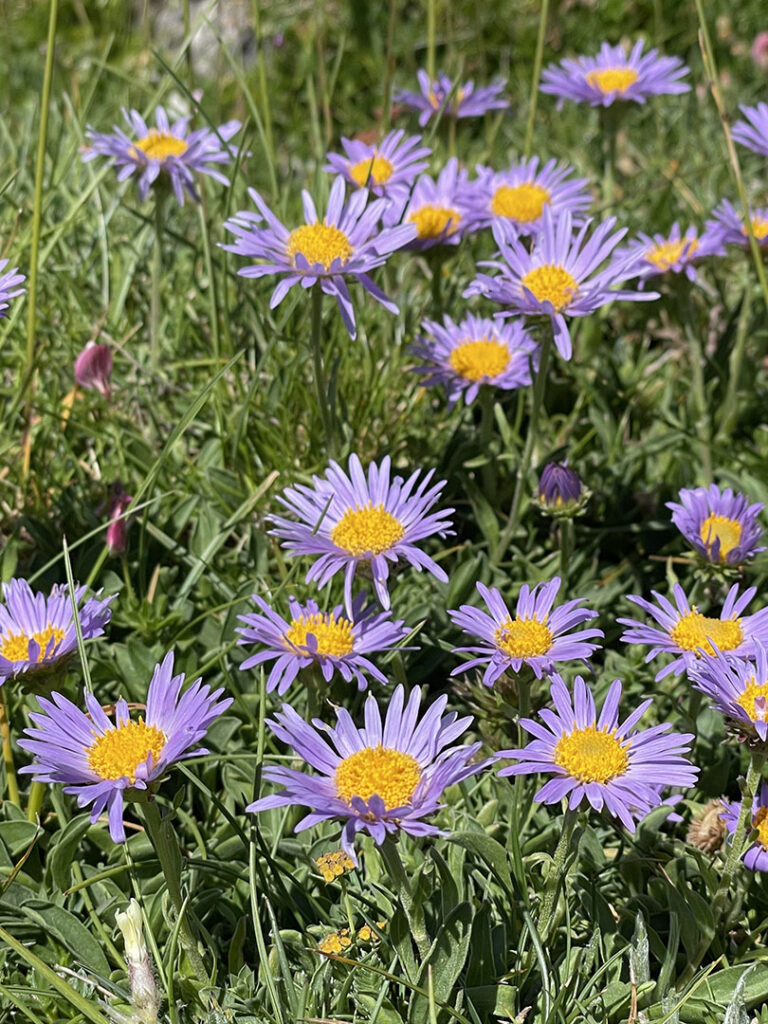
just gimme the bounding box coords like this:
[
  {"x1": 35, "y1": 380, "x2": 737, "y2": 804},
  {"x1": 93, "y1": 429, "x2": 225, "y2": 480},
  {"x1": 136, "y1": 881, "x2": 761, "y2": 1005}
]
[{"x1": 499, "y1": 676, "x2": 698, "y2": 831}]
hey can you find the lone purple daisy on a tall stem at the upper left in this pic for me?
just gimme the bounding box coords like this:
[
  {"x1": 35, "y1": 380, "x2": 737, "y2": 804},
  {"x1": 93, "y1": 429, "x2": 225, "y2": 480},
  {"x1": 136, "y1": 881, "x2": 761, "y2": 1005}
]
[{"x1": 83, "y1": 106, "x2": 240, "y2": 206}]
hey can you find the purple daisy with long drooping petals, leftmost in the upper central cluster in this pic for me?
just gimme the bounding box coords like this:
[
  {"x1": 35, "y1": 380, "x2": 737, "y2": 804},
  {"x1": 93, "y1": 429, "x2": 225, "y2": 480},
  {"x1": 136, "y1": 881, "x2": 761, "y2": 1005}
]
[{"x1": 222, "y1": 177, "x2": 416, "y2": 338}]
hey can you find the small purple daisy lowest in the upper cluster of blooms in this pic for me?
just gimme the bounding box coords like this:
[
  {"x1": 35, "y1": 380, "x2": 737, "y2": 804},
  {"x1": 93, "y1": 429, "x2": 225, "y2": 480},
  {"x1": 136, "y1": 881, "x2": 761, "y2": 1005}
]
[{"x1": 413, "y1": 314, "x2": 539, "y2": 408}]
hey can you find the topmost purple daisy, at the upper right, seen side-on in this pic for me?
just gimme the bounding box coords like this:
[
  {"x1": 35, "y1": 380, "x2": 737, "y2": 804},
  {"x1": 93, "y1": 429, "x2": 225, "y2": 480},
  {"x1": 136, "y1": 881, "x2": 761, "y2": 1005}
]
[{"x1": 541, "y1": 40, "x2": 690, "y2": 106}]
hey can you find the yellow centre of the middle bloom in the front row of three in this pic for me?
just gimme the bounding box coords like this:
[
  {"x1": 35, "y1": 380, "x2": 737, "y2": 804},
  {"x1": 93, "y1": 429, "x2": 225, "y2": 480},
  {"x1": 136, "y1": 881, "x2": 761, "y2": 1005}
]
[{"x1": 334, "y1": 743, "x2": 421, "y2": 811}]
